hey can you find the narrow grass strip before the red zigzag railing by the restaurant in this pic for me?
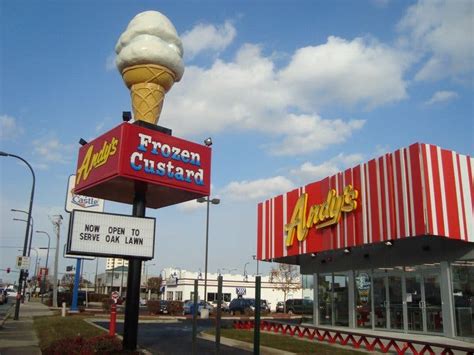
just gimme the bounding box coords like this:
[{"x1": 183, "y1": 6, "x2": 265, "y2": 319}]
[{"x1": 206, "y1": 329, "x2": 364, "y2": 355}]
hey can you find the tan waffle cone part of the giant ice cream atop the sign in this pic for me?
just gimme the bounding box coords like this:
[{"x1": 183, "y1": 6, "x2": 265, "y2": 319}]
[{"x1": 122, "y1": 64, "x2": 175, "y2": 124}]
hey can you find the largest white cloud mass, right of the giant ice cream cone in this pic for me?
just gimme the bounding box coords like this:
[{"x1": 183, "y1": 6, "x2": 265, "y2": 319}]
[{"x1": 160, "y1": 37, "x2": 400, "y2": 155}]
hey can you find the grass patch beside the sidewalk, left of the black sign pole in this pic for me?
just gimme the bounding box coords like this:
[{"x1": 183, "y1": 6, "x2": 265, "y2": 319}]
[{"x1": 33, "y1": 315, "x2": 106, "y2": 349}]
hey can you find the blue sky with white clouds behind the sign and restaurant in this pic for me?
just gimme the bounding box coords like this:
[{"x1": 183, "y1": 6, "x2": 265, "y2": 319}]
[{"x1": 0, "y1": 0, "x2": 474, "y2": 279}]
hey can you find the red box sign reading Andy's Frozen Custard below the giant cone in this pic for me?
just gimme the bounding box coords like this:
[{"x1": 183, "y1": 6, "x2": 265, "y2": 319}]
[{"x1": 74, "y1": 123, "x2": 211, "y2": 208}]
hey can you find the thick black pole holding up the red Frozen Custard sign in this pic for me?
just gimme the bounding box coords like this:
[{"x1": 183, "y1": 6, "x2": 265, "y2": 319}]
[{"x1": 122, "y1": 186, "x2": 146, "y2": 351}]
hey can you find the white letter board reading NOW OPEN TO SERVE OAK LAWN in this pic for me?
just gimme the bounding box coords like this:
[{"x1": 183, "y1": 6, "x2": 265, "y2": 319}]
[{"x1": 66, "y1": 211, "x2": 155, "y2": 259}]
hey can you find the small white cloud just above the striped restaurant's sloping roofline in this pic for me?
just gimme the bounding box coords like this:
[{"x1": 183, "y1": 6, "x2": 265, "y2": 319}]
[{"x1": 290, "y1": 153, "x2": 364, "y2": 181}]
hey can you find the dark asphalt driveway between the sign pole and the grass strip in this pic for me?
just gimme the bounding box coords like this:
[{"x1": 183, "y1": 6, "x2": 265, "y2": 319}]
[{"x1": 96, "y1": 319, "x2": 252, "y2": 354}]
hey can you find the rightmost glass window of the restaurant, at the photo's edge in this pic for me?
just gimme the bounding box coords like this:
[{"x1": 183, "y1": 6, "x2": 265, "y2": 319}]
[{"x1": 451, "y1": 261, "x2": 474, "y2": 337}]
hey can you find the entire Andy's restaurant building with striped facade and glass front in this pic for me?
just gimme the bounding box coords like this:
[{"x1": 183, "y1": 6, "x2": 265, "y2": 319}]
[{"x1": 257, "y1": 143, "x2": 474, "y2": 341}]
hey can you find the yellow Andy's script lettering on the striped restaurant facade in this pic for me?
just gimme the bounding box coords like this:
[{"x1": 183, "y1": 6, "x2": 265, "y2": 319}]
[{"x1": 285, "y1": 185, "x2": 359, "y2": 247}]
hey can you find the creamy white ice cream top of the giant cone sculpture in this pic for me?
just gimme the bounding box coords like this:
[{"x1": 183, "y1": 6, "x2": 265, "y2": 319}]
[{"x1": 115, "y1": 11, "x2": 184, "y2": 81}]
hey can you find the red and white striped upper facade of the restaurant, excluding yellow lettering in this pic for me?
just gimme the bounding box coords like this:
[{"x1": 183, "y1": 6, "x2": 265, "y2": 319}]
[{"x1": 257, "y1": 143, "x2": 474, "y2": 260}]
